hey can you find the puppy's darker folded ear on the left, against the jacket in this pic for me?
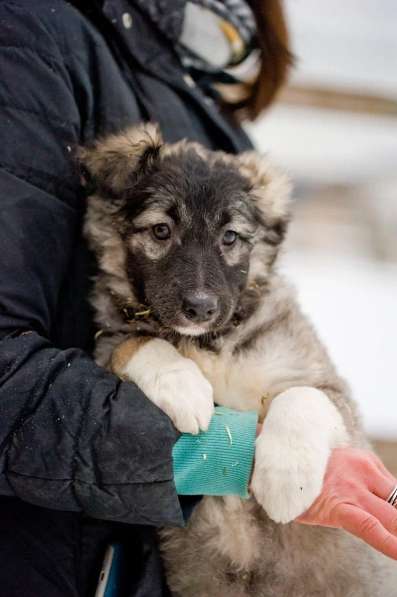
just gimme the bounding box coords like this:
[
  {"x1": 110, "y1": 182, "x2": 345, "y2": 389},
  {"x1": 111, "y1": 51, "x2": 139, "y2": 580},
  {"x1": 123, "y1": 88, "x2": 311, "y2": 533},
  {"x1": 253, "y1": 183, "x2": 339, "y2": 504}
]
[{"x1": 78, "y1": 123, "x2": 163, "y2": 199}]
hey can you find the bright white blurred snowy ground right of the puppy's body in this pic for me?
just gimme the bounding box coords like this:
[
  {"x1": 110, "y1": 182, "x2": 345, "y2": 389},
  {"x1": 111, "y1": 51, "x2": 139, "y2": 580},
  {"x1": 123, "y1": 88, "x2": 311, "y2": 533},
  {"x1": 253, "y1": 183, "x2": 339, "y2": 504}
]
[{"x1": 282, "y1": 252, "x2": 397, "y2": 440}]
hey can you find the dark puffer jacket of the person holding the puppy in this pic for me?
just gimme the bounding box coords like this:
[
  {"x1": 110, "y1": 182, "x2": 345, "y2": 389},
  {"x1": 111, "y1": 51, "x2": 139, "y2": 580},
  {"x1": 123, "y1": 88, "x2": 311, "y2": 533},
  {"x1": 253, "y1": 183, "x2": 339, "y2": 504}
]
[{"x1": 0, "y1": 0, "x2": 249, "y2": 525}]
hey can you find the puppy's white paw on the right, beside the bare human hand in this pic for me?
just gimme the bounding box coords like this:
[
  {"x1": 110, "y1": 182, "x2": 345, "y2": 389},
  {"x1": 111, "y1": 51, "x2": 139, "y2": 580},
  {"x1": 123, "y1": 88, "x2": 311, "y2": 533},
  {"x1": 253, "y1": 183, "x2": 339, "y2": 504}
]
[{"x1": 251, "y1": 387, "x2": 346, "y2": 523}]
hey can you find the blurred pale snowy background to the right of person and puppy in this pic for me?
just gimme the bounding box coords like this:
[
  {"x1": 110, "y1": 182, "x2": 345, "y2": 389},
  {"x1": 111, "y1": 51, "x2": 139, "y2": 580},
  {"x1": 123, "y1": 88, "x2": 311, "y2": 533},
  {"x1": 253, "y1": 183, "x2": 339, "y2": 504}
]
[{"x1": 248, "y1": 0, "x2": 397, "y2": 466}]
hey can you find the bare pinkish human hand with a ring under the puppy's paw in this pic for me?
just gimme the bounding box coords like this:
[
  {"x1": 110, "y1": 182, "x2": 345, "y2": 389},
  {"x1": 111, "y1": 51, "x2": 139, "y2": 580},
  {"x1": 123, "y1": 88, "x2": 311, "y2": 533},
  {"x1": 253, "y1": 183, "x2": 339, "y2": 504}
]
[{"x1": 295, "y1": 448, "x2": 397, "y2": 560}]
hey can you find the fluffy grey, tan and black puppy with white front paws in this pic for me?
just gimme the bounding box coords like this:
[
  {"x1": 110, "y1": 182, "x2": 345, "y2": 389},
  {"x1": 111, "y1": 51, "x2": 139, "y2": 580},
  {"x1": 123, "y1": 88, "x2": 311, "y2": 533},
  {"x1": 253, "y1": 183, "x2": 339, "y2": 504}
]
[{"x1": 81, "y1": 125, "x2": 397, "y2": 597}]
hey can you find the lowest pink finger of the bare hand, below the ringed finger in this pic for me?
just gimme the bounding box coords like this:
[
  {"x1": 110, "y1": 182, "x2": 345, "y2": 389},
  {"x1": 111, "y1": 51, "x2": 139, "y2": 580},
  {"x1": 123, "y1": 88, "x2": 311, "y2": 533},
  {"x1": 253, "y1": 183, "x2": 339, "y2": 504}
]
[{"x1": 338, "y1": 504, "x2": 397, "y2": 560}]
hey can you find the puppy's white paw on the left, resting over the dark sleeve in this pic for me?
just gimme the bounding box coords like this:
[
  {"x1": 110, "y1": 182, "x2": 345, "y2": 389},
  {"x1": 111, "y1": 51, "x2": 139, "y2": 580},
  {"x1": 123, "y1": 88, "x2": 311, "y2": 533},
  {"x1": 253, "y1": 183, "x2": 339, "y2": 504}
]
[{"x1": 123, "y1": 339, "x2": 214, "y2": 434}]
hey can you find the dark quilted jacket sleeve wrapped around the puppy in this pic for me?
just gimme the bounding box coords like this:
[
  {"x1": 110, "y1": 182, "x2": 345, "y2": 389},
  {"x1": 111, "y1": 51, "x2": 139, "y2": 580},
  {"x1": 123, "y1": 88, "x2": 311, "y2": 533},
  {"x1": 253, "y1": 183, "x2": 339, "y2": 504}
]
[{"x1": 0, "y1": 2, "x2": 181, "y2": 524}]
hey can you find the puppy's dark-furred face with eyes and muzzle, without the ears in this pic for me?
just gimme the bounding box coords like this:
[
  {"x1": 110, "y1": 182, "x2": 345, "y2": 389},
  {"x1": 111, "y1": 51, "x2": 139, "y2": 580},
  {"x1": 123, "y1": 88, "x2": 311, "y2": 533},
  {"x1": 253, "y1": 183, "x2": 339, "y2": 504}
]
[{"x1": 120, "y1": 147, "x2": 258, "y2": 335}]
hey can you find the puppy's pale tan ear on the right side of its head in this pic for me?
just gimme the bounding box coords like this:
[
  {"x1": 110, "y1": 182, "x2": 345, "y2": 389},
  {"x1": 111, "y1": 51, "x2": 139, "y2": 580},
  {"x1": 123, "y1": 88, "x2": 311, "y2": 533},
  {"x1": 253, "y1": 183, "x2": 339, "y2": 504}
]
[{"x1": 236, "y1": 151, "x2": 292, "y2": 245}]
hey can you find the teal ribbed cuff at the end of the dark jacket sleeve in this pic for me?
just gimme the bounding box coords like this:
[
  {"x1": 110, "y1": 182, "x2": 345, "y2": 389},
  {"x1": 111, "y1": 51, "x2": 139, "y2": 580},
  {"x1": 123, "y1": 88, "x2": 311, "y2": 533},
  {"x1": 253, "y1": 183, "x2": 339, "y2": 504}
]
[{"x1": 172, "y1": 406, "x2": 258, "y2": 498}]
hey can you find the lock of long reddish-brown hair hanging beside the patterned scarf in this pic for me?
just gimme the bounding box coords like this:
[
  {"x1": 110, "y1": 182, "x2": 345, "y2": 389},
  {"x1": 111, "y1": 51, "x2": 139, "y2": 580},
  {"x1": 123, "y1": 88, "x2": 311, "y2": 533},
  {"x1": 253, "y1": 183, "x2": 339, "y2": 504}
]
[{"x1": 229, "y1": 0, "x2": 293, "y2": 120}]
